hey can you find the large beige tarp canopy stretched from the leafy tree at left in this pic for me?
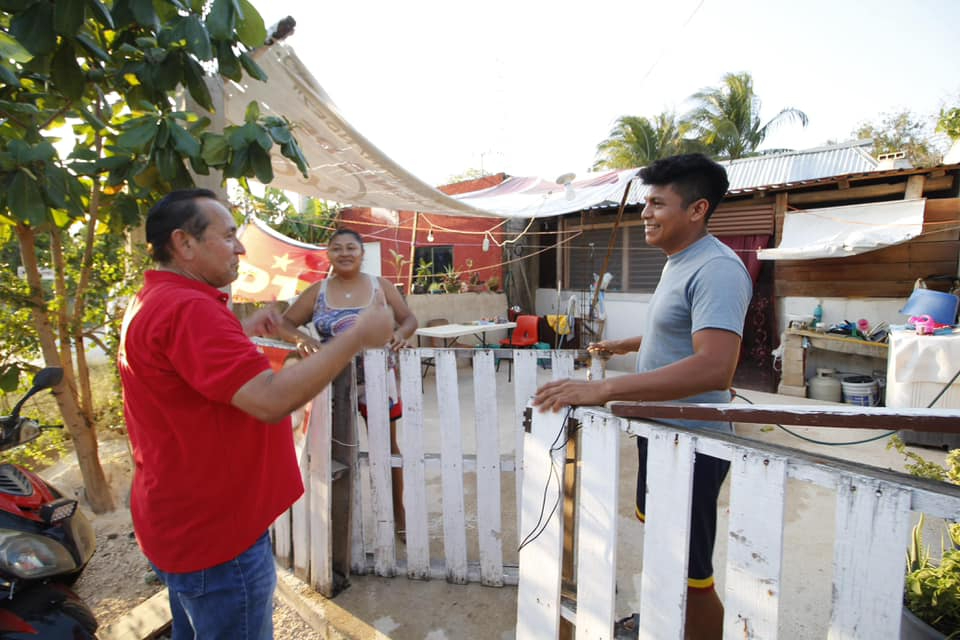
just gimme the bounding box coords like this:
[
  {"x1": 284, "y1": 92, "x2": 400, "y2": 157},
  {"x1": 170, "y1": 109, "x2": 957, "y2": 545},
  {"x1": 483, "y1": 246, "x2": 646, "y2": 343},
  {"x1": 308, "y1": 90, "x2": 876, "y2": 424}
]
[{"x1": 224, "y1": 43, "x2": 491, "y2": 216}]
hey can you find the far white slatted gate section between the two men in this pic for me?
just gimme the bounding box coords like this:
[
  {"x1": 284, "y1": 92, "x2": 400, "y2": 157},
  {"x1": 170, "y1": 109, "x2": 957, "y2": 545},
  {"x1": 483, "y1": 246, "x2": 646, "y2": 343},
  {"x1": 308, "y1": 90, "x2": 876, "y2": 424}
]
[{"x1": 273, "y1": 349, "x2": 575, "y2": 596}]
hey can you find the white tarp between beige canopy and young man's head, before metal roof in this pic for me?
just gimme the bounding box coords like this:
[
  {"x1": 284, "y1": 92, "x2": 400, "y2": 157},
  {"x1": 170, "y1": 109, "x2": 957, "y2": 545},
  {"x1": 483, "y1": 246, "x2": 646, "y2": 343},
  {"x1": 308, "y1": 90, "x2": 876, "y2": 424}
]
[{"x1": 456, "y1": 169, "x2": 638, "y2": 218}]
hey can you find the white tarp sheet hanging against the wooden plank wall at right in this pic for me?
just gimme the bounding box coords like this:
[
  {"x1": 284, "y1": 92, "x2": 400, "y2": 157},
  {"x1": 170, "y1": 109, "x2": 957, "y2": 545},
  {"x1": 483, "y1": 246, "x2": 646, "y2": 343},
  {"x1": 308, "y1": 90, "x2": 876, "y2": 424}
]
[{"x1": 758, "y1": 198, "x2": 926, "y2": 260}]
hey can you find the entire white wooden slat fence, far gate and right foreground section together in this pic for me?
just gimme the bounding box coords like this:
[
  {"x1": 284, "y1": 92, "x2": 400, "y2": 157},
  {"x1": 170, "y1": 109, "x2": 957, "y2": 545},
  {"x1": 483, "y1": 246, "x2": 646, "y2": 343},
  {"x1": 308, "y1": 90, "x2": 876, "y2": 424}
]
[{"x1": 273, "y1": 349, "x2": 960, "y2": 640}]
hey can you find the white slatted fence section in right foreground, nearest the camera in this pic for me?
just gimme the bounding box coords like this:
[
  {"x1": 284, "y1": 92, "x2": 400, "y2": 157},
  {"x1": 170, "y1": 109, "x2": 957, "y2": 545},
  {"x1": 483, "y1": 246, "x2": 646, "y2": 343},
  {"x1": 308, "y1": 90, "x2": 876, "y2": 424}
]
[{"x1": 517, "y1": 408, "x2": 960, "y2": 640}]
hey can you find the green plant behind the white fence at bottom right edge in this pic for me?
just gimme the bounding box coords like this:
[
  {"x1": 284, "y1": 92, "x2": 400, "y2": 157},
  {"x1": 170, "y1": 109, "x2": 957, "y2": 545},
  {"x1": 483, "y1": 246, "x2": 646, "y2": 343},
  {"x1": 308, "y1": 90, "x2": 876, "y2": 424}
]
[{"x1": 888, "y1": 436, "x2": 960, "y2": 640}]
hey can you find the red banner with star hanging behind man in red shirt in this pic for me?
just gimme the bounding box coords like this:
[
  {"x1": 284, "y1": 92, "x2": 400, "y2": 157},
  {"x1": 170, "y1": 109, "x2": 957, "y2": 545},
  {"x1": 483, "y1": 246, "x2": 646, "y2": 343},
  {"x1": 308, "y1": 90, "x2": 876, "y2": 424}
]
[{"x1": 232, "y1": 218, "x2": 330, "y2": 302}]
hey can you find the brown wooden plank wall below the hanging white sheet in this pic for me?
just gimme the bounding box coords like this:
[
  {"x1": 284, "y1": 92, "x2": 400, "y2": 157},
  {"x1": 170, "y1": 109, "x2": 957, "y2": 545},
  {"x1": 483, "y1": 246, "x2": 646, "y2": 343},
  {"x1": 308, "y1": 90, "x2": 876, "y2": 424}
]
[{"x1": 774, "y1": 196, "x2": 960, "y2": 298}]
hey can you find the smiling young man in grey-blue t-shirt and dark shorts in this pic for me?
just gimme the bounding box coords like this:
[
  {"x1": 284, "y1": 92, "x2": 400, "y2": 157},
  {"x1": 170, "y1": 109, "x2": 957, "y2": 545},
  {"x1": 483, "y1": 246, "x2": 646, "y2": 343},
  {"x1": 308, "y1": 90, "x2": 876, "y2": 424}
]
[{"x1": 533, "y1": 154, "x2": 752, "y2": 640}]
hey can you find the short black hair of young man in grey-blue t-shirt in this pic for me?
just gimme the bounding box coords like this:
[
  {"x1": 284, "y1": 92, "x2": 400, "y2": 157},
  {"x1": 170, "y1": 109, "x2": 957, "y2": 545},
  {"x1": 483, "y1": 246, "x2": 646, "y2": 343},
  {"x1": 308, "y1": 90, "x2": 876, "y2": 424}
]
[{"x1": 640, "y1": 153, "x2": 730, "y2": 221}]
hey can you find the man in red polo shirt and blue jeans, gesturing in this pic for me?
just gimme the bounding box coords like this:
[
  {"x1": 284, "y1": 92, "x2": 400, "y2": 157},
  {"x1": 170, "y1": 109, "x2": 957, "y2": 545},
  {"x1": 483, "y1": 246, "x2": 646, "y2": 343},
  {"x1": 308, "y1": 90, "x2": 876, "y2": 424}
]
[{"x1": 118, "y1": 189, "x2": 393, "y2": 640}]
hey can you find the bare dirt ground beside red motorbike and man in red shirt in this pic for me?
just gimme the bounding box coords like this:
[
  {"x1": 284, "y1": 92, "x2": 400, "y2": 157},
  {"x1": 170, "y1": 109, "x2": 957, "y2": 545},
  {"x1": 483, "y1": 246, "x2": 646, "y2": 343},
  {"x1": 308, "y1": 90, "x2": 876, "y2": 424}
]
[{"x1": 40, "y1": 436, "x2": 320, "y2": 640}]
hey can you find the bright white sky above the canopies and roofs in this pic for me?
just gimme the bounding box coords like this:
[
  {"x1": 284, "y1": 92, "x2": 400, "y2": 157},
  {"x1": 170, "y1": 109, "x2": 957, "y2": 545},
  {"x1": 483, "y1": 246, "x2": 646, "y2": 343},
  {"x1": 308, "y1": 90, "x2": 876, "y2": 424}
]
[{"x1": 252, "y1": 0, "x2": 960, "y2": 185}]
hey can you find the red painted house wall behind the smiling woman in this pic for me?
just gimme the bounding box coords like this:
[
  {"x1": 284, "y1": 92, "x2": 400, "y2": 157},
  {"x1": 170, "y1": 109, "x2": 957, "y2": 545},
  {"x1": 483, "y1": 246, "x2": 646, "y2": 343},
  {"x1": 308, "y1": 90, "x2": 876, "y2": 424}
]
[{"x1": 340, "y1": 173, "x2": 507, "y2": 293}]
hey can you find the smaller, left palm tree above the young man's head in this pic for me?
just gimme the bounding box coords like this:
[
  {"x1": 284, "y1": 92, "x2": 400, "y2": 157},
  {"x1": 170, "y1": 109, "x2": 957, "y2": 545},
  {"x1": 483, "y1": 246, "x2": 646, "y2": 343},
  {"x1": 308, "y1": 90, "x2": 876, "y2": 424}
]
[{"x1": 593, "y1": 111, "x2": 696, "y2": 169}]
